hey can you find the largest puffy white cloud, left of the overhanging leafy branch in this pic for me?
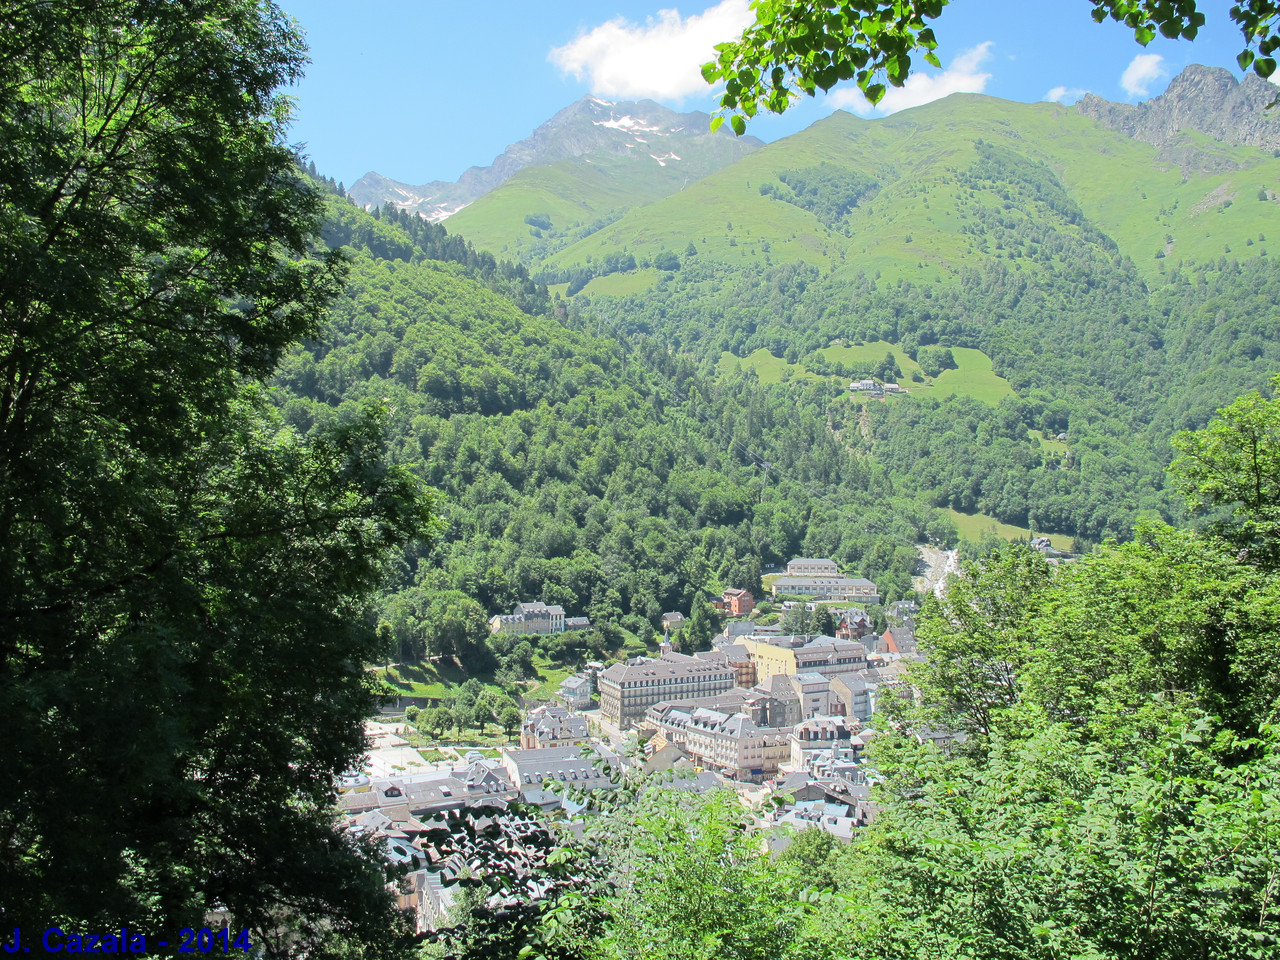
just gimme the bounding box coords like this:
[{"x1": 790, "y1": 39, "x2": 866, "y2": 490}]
[{"x1": 547, "y1": 0, "x2": 755, "y2": 99}]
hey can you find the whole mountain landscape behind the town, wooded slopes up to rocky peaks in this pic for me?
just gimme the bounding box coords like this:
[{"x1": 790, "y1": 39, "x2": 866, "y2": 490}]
[{"x1": 285, "y1": 68, "x2": 1280, "y2": 669}]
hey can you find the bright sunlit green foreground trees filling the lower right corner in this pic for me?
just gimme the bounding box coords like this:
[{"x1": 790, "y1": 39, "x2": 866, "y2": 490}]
[{"x1": 431, "y1": 386, "x2": 1280, "y2": 960}]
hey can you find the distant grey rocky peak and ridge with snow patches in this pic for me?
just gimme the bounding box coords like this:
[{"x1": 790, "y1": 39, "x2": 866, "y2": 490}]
[{"x1": 347, "y1": 96, "x2": 763, "y2": 220}]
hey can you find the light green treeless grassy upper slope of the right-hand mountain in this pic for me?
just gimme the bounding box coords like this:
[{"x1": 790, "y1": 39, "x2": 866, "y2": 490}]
[{"x1": 514, "y1": 95, "x2": 1280, "y2": 293}]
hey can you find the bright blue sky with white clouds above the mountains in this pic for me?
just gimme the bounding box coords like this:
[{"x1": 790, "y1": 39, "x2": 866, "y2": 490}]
[{"x1": 278, "y1": 0, "x2": 1242, "y2": 186}]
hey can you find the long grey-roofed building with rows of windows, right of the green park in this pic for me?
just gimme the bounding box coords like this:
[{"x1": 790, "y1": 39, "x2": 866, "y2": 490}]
[{"x1": 595, "y1": 653, "x2": 736, "y2": 728}]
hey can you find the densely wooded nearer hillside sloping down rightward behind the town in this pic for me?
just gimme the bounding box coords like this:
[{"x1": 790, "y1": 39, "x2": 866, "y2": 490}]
[{"x1": 275, "y1": 197, "x2": 931, "y2": 667}]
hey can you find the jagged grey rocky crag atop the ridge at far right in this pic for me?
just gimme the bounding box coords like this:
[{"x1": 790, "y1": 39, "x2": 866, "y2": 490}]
[{"x1": 1075, "y1": 64, "x2": 1280, "y2": 170}]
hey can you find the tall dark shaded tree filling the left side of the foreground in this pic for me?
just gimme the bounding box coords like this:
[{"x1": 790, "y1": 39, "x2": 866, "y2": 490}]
[{"x1": 0, "y1": 0, "x2": 430, "y2": 956}]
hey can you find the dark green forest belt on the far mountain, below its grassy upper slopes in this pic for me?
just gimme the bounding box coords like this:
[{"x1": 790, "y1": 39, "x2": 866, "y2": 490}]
[{"x1": 563, "y1": 143, "x2": 1280, "y2": 547}]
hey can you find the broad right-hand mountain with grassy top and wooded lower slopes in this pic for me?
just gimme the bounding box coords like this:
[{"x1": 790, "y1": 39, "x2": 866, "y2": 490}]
[{"x1": 465, "y1": 77, "x2": 1280, "y2": 548}]
